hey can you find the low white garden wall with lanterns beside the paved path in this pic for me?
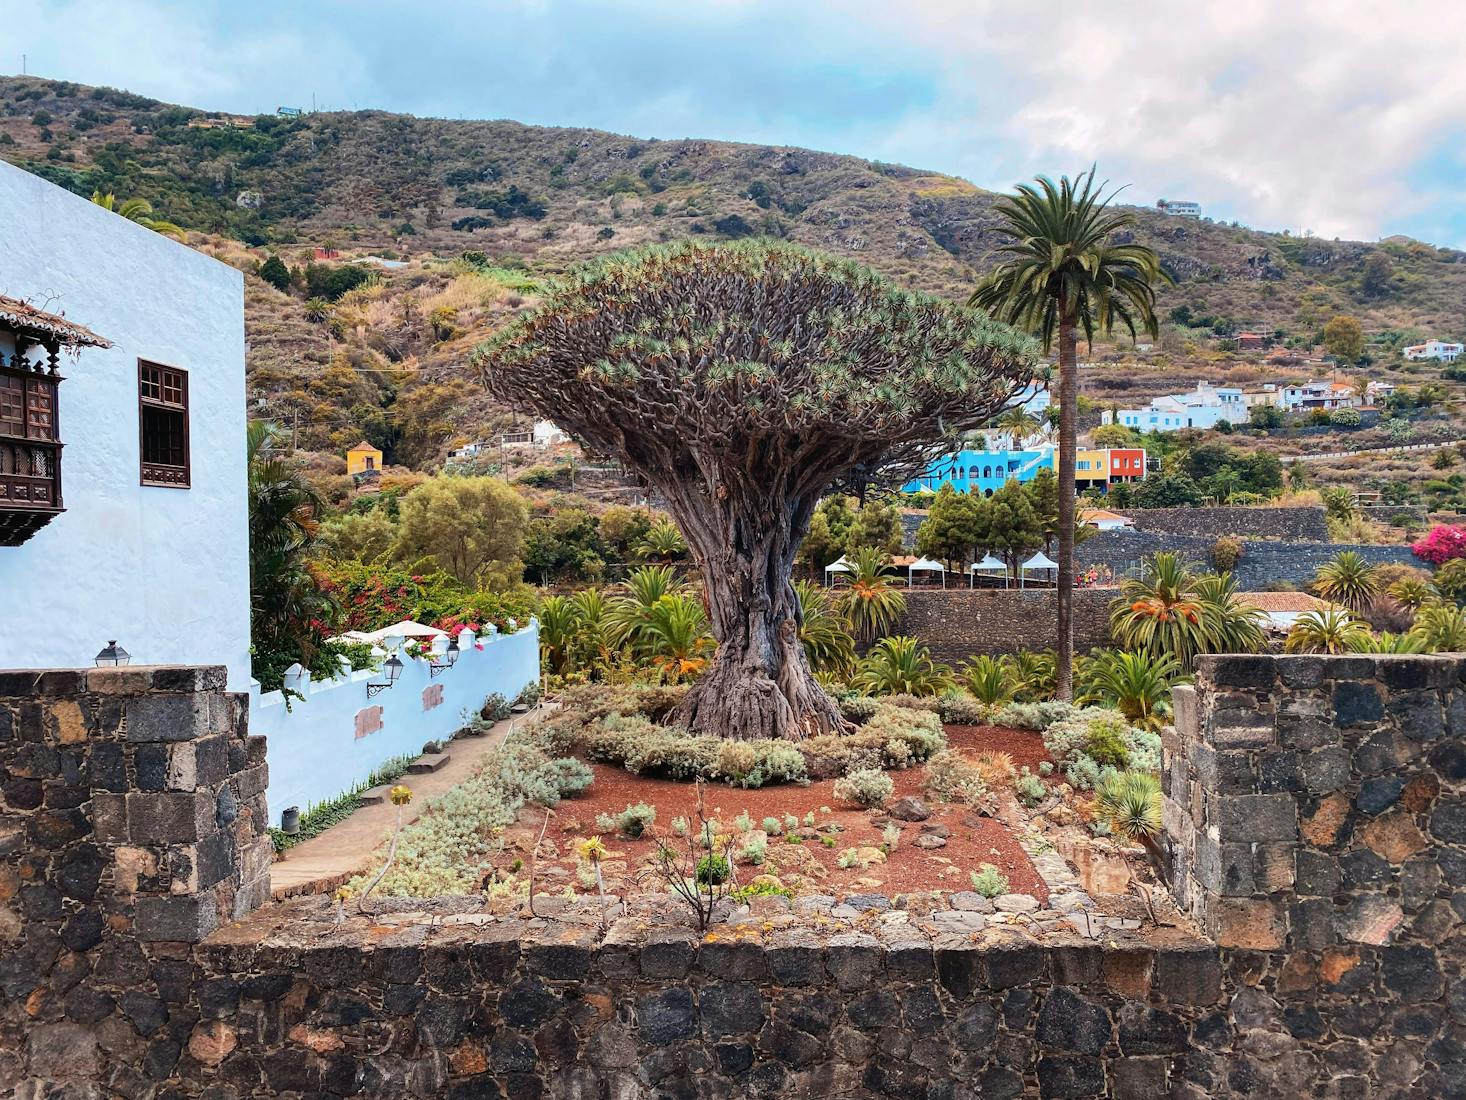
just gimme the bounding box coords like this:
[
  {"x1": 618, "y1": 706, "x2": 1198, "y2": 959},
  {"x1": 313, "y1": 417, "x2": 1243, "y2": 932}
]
[{"x1": 249, "y1": 620, "x2": 539, "y2": 824}]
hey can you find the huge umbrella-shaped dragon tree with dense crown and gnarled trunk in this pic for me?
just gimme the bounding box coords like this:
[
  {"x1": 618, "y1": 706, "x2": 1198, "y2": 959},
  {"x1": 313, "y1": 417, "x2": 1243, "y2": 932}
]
[{"x1": 474, "y1": 242, "x2": 1038, "y2": 739}]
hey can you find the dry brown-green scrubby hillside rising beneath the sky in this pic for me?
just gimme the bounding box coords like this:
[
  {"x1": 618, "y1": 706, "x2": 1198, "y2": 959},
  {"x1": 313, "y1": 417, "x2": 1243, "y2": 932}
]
[{"x1": 0, "y1": 78, "x2": 1466, "y2": 465}]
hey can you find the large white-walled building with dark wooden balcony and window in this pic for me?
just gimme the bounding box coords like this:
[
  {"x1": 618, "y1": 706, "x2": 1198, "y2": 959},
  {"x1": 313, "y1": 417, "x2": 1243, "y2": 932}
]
[{"x1": 0, "y1": 163, "x2": 249, "y2": 691}]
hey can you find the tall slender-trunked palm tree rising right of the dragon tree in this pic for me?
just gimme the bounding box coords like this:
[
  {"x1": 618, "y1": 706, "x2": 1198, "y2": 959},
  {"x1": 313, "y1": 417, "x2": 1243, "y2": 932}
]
[{"x1": 970, "y1": 167, "x2": 1168, "y2": 700}]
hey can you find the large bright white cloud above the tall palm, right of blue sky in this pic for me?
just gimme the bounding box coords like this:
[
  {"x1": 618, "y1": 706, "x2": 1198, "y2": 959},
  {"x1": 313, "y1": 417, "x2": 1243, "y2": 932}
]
[{"x1": 861, "y1": 0, "x2": 1466, "y2": 239}]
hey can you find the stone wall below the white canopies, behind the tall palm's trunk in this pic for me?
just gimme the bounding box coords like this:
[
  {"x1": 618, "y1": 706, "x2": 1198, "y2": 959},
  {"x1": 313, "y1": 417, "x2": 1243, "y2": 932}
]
[{"x1": 894, "y1": 588, "x2": 1116, "y2": 661}]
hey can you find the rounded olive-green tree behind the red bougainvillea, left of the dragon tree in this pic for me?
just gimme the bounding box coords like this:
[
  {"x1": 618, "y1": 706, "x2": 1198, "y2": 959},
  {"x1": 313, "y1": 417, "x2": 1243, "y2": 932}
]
[{"x1": 393, "y1": 477, "x2": 528, "y2": 590}]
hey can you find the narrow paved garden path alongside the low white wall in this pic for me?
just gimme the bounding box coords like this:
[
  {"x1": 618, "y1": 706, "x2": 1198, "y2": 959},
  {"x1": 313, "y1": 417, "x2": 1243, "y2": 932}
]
[{"x1": 270, "y1": 714, "x2": 529, "y2": 899}]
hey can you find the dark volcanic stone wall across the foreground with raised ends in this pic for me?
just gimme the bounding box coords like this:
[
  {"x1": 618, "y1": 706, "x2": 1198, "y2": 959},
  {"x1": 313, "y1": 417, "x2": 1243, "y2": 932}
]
[{"x1": 0, "y1": 657, "x2": 1466, "y2": 1100}]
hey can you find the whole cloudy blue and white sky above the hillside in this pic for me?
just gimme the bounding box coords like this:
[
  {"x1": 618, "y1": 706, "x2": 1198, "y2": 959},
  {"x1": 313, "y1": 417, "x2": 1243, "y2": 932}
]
[{"x1": 11, "y1": 0, "x2": 1466, "y2": 248}]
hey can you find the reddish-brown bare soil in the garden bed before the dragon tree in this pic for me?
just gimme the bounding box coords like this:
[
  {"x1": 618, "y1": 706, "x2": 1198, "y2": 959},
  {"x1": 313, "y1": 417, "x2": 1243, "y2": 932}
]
[{"x1": 523, "y1": 726, "x2": 1048, "y2": 902}]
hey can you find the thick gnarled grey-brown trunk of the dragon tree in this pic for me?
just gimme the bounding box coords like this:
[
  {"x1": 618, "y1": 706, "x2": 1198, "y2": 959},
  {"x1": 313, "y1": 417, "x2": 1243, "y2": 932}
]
[{"x1": 664, "y1": 471, "x2": 844, "y2": 741}]
